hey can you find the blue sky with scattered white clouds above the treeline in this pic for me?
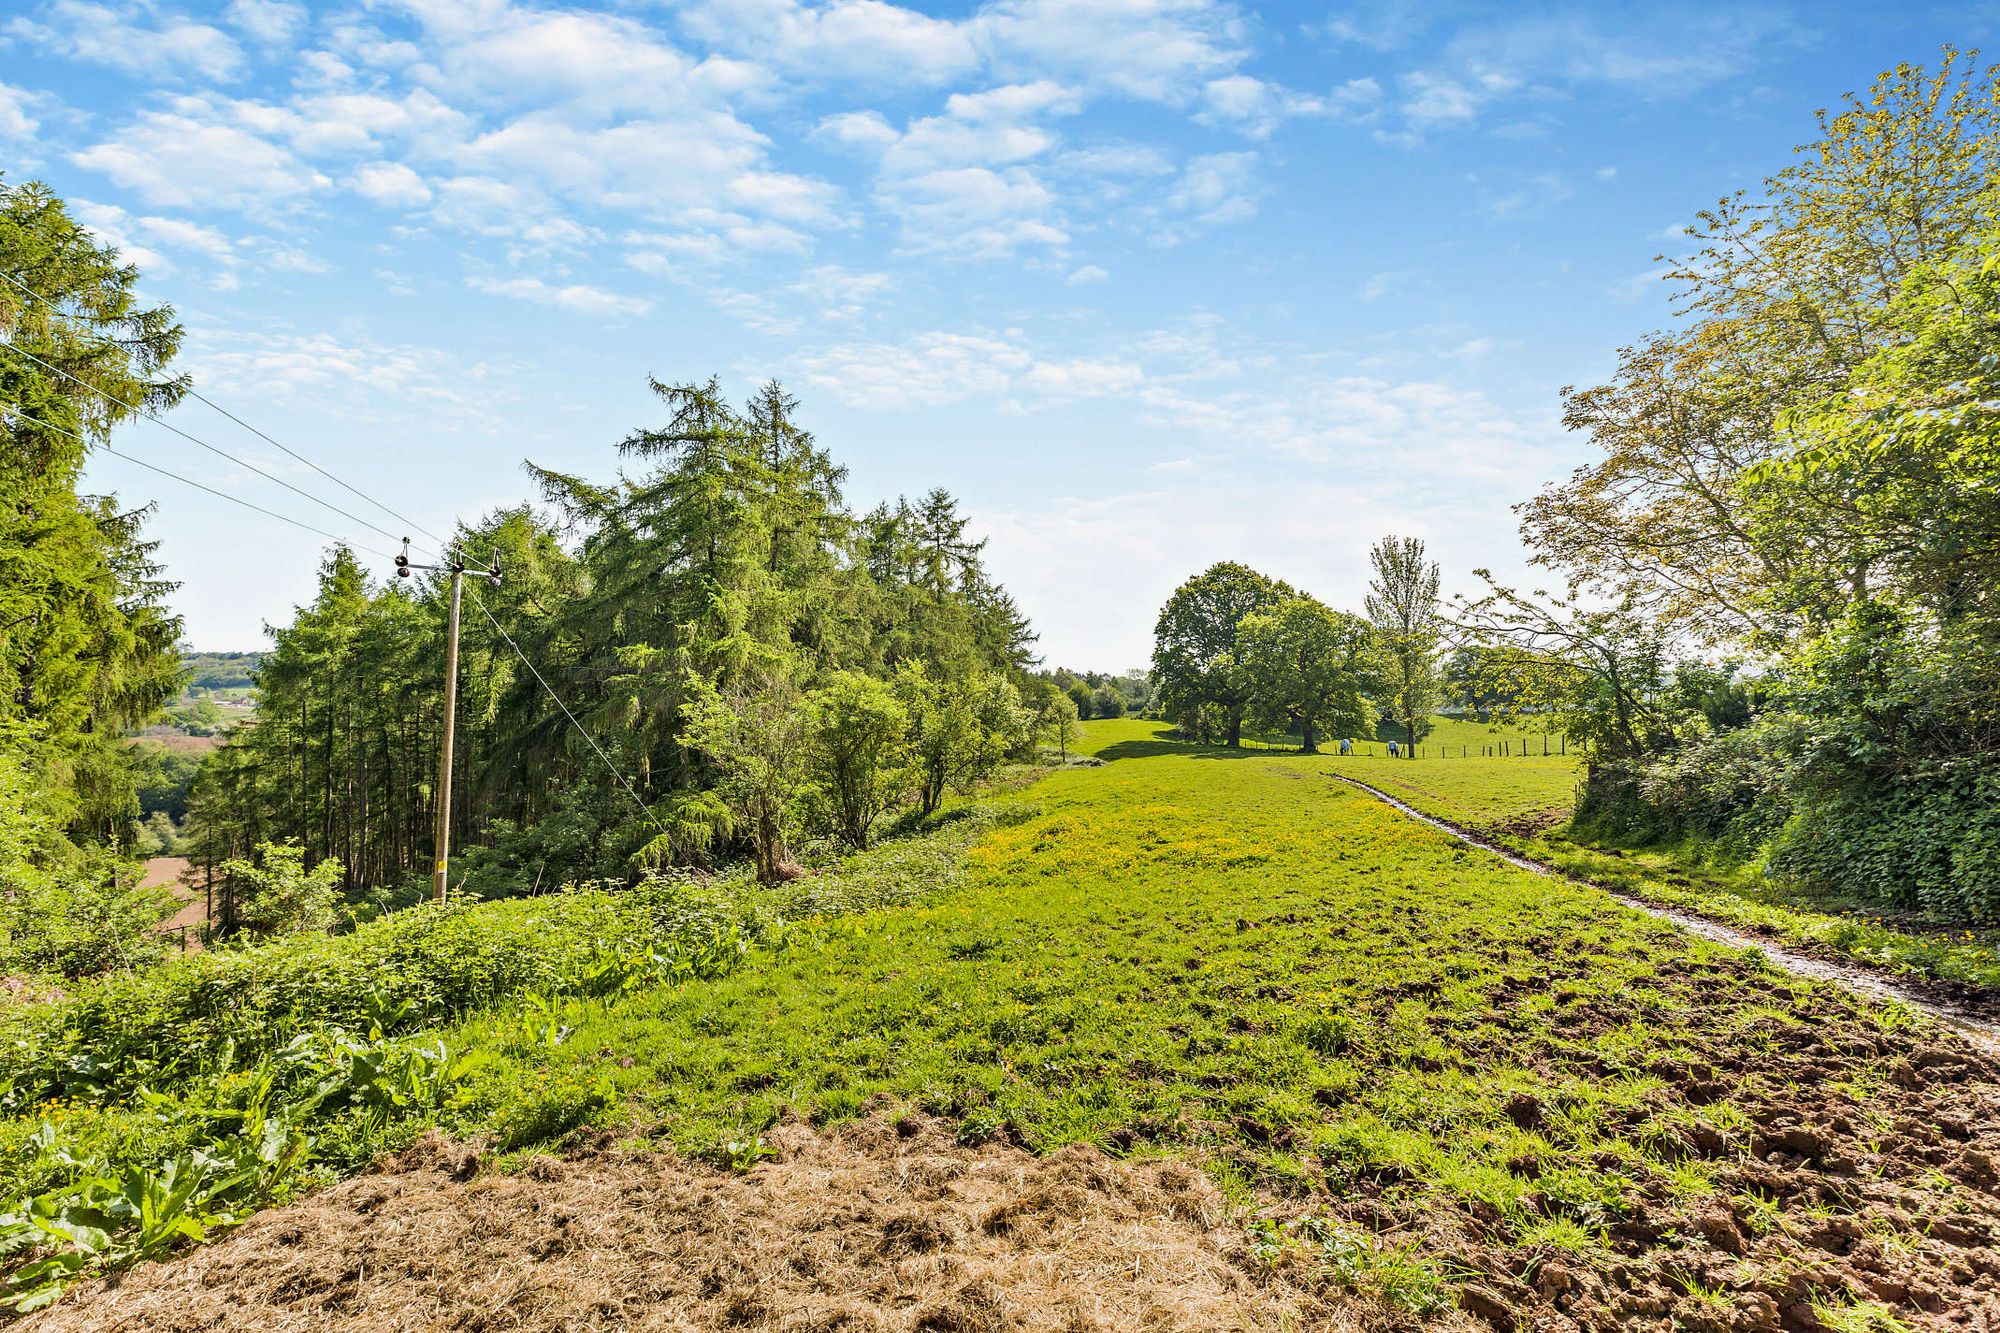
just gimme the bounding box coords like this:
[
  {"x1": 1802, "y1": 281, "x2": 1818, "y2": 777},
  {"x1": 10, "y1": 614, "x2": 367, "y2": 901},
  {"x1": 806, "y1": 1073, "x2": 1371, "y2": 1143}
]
[{"x1": 0, "y1": 0, "x2": 2000, "y2": 669}]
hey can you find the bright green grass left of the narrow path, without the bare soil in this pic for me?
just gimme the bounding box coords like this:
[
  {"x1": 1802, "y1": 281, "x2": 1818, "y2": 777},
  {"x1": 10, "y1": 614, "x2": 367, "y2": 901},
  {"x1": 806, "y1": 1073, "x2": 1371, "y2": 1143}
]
[{"x1": 414, "y1": 721, "x2": 1992, "y2": 1312}]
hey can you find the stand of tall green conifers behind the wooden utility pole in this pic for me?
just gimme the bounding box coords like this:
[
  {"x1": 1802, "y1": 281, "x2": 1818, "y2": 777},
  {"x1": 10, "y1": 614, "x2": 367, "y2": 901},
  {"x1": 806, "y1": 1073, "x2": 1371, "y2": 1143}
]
[{"x1": 190, "y1": 380, "x2": 1032, "y2": 908}]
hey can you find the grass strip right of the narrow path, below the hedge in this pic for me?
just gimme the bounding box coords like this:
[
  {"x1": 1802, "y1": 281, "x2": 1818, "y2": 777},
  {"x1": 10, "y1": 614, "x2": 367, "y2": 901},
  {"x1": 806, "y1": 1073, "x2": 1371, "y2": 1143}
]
[{"x1": 1338, "y1": 740, "x2": 2000, "y2": 989}]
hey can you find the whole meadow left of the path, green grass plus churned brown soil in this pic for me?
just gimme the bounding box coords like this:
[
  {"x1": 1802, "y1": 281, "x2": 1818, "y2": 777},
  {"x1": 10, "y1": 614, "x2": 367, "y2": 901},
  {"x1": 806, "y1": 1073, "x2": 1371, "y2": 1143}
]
[{"x1": 10, "y1": 721, "x2": 2000, "y2": 1329}]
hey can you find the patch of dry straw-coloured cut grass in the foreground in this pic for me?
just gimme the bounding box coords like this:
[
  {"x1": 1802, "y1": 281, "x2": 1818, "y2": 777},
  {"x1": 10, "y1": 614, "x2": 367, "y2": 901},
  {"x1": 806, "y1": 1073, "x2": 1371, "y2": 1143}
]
[{"x1": 20, "y1": 1119, "x2": 1376, "y2": 1333}]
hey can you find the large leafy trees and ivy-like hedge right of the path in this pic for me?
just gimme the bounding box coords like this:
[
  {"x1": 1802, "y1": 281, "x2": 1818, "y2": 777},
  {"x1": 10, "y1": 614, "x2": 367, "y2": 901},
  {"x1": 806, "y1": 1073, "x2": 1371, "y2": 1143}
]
[{"x1": 1504, "y1": 50, "x2": 2000, "y2": 923}]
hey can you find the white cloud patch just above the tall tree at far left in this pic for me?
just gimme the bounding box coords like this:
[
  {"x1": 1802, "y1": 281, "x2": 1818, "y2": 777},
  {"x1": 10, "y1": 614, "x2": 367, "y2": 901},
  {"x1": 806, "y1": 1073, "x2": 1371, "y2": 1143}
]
[{"x1": 70, "y1": 98, "x2": 332, "y2": 212}]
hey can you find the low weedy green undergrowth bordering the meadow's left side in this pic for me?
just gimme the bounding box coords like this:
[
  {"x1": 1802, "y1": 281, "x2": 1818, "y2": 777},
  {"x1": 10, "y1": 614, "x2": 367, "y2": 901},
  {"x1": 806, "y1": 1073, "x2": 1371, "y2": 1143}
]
[{"x1": 0, "y1": 800, "x2": 994, "y2": 1311}]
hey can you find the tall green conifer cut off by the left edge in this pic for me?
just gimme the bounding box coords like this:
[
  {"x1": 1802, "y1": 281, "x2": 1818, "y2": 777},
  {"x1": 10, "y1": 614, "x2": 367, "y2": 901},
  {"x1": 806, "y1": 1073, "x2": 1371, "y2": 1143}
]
[{"x1": 0, "y1": 182, "x2": 186, "y2": 845}]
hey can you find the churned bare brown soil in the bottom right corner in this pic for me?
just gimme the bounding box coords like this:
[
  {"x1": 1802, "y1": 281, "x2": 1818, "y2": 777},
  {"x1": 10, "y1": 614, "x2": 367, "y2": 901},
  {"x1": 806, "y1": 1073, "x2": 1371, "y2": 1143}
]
[{"x1": 1326, "y1": 961, "x2": 2000, "y2": 1333}]
